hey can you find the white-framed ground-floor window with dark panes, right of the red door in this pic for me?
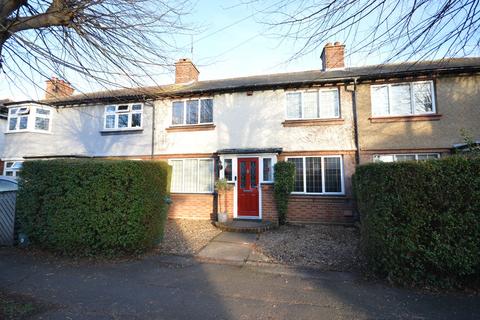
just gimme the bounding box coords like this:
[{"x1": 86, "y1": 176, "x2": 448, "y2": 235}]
[{"x1": 287, "y1": 156, "x2": 344, "y2": 194}]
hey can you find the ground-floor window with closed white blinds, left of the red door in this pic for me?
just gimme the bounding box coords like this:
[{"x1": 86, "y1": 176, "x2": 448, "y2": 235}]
[{"x1": 169, "y1": 159, "x2": 214, "y2": 193}]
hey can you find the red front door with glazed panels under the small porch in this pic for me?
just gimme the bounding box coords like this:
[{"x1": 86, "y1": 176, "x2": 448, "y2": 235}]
[{"x1": 237, "y1": 158, "x2": 259, "y2": 217}]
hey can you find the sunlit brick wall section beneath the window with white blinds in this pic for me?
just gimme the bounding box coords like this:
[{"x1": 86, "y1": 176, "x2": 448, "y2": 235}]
[{"x1": 168, "y1": 193, "x2": 216, "y2": 220}]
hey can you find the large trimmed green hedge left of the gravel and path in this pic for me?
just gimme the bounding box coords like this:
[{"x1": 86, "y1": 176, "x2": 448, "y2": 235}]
[{"x1": 17, "y1": 159, "x2": 171, "y2": 256}]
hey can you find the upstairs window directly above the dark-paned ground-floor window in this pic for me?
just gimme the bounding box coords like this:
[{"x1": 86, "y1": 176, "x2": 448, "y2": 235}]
[{"x1": 286, "y1": 88, "x2": 340, "y2": 120}]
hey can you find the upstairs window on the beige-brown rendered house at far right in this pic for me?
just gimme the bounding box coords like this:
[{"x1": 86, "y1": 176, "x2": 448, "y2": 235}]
[{"x1": 370, "y1": 81, "x2": 435, "y2": 117}]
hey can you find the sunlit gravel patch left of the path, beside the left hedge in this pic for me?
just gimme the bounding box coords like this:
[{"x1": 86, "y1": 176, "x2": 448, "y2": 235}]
[{"x1": 158, "y1": 219, "x2": 222, "y2": 255}]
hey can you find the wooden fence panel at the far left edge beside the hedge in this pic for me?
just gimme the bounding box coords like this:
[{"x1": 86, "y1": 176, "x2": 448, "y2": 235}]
[{"x1": 0, "y1": 191, "x2": 17, "y2": 246}]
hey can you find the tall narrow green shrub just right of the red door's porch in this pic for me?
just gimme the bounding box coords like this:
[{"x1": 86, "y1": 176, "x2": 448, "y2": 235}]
[{"x1": 273, "y1": 161, "x2": 295, "y2": 224}]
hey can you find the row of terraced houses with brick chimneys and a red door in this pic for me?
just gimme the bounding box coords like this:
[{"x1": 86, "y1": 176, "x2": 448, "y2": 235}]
[{"x1": 1, "y1": 42, "x2": 480, "y2": 222}]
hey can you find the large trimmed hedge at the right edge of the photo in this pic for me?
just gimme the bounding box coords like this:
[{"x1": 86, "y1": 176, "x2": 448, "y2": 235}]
[{"x1": 353, "y1": 156, "x2": 480, "y2": 287}]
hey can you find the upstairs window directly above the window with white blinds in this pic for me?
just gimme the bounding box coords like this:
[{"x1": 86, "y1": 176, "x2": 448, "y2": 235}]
[{"x1": 172, "y1": 99, "x2": 213, "y2": 126}]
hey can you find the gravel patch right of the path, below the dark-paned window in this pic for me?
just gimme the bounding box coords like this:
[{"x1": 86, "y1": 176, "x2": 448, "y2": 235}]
[{"x1": 255, "y1": 225, "x2": 361, "y2": 271}]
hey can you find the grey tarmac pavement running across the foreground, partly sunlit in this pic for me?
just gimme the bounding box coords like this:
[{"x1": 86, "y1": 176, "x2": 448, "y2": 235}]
[{"x1": 0, "y1": 245, "x2": 480, "y2": 320}]
